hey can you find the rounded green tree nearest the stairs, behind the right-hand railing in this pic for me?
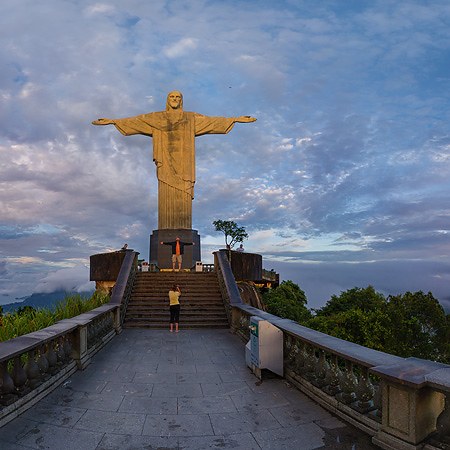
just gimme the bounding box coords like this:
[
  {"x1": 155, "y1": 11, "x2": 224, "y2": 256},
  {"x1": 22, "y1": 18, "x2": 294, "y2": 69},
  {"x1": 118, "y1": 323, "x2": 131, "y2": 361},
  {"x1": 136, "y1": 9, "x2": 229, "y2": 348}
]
[{"x1": 263, "y1": 280, "x2": 311, "y2": 323}]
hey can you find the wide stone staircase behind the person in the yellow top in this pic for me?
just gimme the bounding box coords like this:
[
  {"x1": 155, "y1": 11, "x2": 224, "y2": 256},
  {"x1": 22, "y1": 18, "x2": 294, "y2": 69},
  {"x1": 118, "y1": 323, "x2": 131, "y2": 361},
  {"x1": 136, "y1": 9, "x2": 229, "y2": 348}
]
[{"x1": 124, "y1": 272, "x2": 229, "y2": 328}]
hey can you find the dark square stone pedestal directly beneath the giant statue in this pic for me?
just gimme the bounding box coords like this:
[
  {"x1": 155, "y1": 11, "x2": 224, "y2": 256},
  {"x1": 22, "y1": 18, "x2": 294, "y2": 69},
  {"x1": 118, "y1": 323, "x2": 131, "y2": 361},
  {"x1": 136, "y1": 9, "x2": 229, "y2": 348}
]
[{"x1": 149, "y1": 228, "x2": 201, "y2": 269}]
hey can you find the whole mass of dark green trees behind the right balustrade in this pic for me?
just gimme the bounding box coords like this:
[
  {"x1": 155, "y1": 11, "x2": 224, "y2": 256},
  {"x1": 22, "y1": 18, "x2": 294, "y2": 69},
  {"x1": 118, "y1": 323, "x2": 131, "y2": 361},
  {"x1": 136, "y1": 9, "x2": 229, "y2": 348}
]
[{"x1": 263, "y1": 281, "x2": 450, "y2": 364}]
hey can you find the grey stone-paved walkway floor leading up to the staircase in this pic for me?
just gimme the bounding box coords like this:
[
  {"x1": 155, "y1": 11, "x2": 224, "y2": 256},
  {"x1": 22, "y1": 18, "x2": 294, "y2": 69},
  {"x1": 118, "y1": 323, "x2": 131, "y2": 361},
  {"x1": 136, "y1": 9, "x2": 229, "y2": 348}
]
[{"x1": 0, "y1": 329, "x2": 376, "y2": 450}]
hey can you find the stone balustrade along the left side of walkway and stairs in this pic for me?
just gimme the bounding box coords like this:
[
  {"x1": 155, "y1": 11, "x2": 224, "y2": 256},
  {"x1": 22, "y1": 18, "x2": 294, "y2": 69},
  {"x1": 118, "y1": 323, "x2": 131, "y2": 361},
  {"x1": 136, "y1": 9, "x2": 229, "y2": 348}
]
[{"x1": 0, "y1": 251, "x2": 137, "y2": 427}]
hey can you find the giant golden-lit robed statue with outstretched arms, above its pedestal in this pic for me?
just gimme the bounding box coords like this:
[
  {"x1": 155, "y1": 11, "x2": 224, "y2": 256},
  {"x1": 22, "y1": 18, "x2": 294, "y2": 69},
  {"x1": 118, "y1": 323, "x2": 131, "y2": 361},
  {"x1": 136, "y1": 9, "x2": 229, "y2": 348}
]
[{"x1": 92, "y1": 91, "x2": 256, "y2": 230}]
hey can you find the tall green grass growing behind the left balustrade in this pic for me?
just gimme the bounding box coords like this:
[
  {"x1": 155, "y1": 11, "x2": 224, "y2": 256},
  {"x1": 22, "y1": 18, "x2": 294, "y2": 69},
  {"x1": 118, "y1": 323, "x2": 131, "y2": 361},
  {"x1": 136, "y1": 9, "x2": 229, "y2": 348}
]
[{"x1": 0, "y1": 292, "x2": 109, "y2": 342}]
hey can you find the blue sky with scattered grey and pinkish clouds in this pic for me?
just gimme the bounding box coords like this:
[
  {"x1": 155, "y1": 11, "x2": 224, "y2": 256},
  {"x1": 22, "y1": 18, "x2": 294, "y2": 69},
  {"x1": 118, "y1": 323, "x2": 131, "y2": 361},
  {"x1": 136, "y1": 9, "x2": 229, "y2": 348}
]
[{"x1": 0, "y1": 0, "x2": 450, "y2": 307}]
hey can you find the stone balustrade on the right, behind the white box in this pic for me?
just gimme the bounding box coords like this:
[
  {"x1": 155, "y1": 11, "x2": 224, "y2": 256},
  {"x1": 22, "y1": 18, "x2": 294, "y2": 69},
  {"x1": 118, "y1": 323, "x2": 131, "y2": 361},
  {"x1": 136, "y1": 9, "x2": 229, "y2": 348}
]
[{"x1": 215, "y1": 252, "x2": 450, "y2": 450}]
